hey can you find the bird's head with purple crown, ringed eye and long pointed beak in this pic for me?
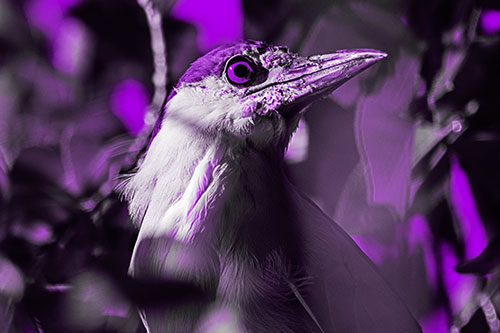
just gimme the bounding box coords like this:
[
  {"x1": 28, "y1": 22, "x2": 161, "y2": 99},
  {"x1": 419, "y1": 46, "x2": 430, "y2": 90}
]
[{"x1": 159, "y1": 41, "x2": 386, "y2": 150}]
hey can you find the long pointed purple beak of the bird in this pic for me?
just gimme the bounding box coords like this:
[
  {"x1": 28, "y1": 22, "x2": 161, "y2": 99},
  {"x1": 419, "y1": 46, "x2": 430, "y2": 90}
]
[{"x1": 261, "y1": 49, "x2": 387, "y2": 115}]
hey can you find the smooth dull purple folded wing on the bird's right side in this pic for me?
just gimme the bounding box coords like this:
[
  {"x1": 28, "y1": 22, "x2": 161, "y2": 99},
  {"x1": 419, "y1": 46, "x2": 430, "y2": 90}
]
[{"x1": 294, "y1": 185, "x2": 421, "y2": 333}]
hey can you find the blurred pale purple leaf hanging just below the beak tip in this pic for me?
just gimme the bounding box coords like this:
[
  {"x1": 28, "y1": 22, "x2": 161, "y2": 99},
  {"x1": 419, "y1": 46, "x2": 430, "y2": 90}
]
[{"x1": 355, "y1": 53, "x2": 419, "y2": 216}]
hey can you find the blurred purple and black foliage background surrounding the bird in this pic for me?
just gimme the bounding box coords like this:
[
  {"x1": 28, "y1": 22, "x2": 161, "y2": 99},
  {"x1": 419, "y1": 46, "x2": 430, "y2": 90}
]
[{"x1": 0, "y1": 0, "x2": 500, "y2": 332}]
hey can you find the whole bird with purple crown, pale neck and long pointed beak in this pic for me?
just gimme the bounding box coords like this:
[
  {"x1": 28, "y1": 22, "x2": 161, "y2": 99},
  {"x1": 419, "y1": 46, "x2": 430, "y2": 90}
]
[{"x1": 122, "y1": 40, "x2": 421, "y2": 332}]
